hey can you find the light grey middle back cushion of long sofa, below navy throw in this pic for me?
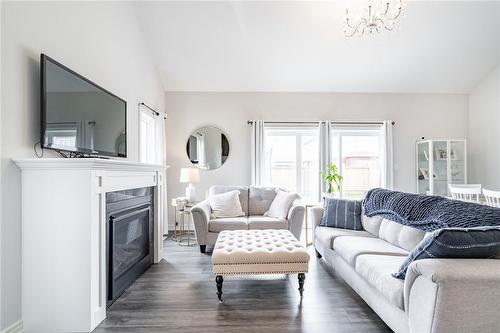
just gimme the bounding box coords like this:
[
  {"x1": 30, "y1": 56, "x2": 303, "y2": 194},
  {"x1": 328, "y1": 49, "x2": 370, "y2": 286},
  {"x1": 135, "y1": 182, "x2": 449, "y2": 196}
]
[{"x1": 378, "y1": 219, "x2": 426, "y2": 251}]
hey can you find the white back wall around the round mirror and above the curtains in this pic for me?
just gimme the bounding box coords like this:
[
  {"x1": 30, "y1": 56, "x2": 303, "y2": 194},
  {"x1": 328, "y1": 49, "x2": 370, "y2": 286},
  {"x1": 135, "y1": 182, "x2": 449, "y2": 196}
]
[{"x1": 165, "y1": 92, "x2": 468, "y2": 227}]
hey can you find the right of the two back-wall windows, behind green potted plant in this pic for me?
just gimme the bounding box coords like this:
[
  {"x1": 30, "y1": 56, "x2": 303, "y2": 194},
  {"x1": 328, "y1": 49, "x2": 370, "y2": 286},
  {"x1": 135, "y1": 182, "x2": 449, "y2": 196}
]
[{"x1": 331, "y1": 126, "x2": 384, "y2": 199}]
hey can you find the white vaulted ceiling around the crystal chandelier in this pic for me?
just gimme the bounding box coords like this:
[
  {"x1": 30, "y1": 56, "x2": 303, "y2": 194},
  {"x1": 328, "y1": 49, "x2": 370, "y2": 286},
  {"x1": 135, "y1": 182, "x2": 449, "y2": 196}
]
[{"x1": 136, "y1": 1, "x2": 500, "y2": 93}]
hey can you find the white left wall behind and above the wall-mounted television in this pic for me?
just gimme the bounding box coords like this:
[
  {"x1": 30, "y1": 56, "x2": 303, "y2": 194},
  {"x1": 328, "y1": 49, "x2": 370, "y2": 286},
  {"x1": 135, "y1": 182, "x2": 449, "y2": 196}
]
[{"x1": 0, "y1": 2, "x2": 164, "y2": 329}]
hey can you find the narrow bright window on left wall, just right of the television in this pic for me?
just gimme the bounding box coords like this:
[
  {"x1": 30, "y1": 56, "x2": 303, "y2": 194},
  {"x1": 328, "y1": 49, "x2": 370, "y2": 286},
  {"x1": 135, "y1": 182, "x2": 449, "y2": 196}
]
[{"x1": 139, "y1": 111, "x2": 163, "y2": 164}]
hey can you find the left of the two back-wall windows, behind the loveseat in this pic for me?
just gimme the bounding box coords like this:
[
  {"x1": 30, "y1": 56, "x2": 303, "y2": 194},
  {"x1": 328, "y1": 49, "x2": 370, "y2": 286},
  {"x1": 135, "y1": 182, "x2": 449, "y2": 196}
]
[{"x1": 264, "y1": 124, "x2": 319, "y2": 201}]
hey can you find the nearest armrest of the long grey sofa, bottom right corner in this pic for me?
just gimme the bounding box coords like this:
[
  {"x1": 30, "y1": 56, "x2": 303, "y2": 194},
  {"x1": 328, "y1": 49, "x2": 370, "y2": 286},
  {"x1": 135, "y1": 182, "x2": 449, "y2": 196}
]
[{"x1": 404, "y1": 259, "x2": 500, "y2": 332}]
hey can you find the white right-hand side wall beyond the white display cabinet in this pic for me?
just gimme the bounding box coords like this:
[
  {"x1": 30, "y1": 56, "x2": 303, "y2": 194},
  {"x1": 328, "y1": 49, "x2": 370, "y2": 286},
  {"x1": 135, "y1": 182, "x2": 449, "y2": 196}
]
[{"x1": 468, "y1": 65, "x2": 500, "y2": 190}]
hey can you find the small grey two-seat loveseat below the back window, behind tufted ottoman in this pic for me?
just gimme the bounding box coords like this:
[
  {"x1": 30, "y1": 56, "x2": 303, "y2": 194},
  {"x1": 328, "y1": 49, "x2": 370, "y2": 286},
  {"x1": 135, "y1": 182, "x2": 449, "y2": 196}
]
[{"x1": 191, "y1": 186, "x2": 305, "y2": 253}]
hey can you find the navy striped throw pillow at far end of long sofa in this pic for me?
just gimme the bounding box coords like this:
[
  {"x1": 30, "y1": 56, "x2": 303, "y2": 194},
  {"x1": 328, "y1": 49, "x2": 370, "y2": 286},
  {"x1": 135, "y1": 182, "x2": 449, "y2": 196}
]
[{"x1": 319, "y1": 198, "x2": 363, "y2": 230}]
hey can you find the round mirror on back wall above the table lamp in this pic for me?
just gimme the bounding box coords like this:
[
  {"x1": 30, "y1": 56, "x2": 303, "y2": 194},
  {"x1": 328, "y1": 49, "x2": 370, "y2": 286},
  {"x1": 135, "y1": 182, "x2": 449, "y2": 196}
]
[{"x1": 186, "y1": 126, "x2": 229, "y2": 170}]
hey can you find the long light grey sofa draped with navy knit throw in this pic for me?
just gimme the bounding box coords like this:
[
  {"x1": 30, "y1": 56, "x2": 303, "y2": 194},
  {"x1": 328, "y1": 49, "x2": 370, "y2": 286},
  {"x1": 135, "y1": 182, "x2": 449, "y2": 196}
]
[{"x1": 311, "y1": 207, "x2": 500, "y2": 333}]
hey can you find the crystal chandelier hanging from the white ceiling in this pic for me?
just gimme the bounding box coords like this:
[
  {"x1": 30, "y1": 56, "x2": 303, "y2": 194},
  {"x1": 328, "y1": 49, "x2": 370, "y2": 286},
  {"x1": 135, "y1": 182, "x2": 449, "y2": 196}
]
[{"x1": 344, "y1": 0, "x2": 403, "y2": 37}]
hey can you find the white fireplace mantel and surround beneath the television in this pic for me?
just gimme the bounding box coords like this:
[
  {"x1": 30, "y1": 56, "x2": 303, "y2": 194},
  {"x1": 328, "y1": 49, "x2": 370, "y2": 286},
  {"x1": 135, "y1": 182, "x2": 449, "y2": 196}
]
[{"x1": 14, "y1": 158, "x2": 168, "y2": 332}]
